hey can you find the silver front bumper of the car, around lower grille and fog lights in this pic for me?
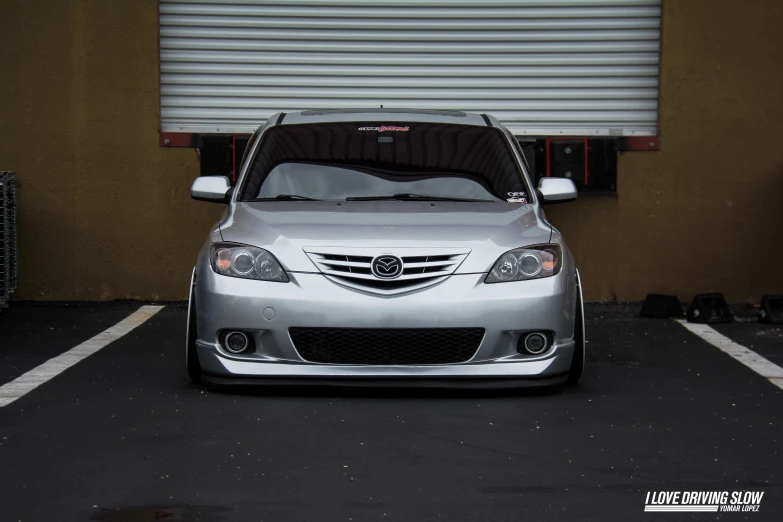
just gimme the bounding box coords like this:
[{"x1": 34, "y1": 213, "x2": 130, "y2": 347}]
[{"x1": 195, "y1": 267, "x2": 576, "y2": 385}]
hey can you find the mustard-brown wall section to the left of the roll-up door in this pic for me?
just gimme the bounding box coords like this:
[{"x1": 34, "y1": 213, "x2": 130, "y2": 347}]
[{"x1": 0, "y1": 0, "x2": 222, "y2": 299}]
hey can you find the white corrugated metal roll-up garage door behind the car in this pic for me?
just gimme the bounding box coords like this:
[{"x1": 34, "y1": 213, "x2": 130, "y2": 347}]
[{"x1": 160, "y1": 0, "x2": 660, "y2": 136}]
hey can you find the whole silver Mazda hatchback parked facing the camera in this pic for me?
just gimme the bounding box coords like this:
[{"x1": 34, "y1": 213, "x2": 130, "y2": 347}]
[{"x1": 186, "y1": 110, "x2": 585, "y2": 386}]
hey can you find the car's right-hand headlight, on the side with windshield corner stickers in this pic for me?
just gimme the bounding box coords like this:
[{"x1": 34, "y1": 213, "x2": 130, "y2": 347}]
[{"x1": 484, "y1": 245, "x2": 563, "y2": 283}]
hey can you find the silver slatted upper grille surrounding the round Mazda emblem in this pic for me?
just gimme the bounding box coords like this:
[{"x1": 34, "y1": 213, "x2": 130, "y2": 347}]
[{"x1": 303, "y1": 247, "x2": 470, "y2": 295}]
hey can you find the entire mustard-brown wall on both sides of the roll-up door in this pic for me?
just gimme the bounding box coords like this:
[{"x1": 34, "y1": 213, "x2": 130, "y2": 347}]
[{"x1": 0, "y1": 0, "x2": 783, "y2": 301}]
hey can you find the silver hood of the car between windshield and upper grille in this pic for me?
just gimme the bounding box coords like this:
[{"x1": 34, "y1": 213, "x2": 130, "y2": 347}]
[{"x1": 220, "y1": 201, "x2": 552, "y2": 273}]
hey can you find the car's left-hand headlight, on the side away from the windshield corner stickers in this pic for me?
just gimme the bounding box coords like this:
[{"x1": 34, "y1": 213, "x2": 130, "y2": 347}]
[{"x1": 212, "y1": 244, "x2": 288, "y2": 283}]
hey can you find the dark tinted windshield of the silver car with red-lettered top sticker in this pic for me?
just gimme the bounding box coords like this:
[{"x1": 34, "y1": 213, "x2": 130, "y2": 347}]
[{"x1": 240, "y1": 122, "x2": 528, "y2": 203}]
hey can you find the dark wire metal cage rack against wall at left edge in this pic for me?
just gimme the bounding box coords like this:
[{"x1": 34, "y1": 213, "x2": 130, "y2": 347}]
[{"x1": 0, "y1": 172, "x2": 18, "y2": 309}]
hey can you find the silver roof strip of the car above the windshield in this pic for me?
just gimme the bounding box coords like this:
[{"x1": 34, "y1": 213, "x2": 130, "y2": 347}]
[{"x1": 278, "y1": 109, "x2": 497, "y2": 127}]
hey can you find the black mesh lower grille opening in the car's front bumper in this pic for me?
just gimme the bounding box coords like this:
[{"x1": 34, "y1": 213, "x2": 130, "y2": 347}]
[{"x1": 288, "y1": 327, "x2": 484, "y2": 365}]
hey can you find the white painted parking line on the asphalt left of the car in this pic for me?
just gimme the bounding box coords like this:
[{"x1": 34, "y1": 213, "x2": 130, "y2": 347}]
[{"x1": 0, "y1": 305, "x2": 163, "y2": 408}]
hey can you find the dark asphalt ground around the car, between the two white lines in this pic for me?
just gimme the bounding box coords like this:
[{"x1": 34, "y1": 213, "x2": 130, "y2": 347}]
[{"x1": 0, "y1": 305, "x2": 783, "y2": 521}]
